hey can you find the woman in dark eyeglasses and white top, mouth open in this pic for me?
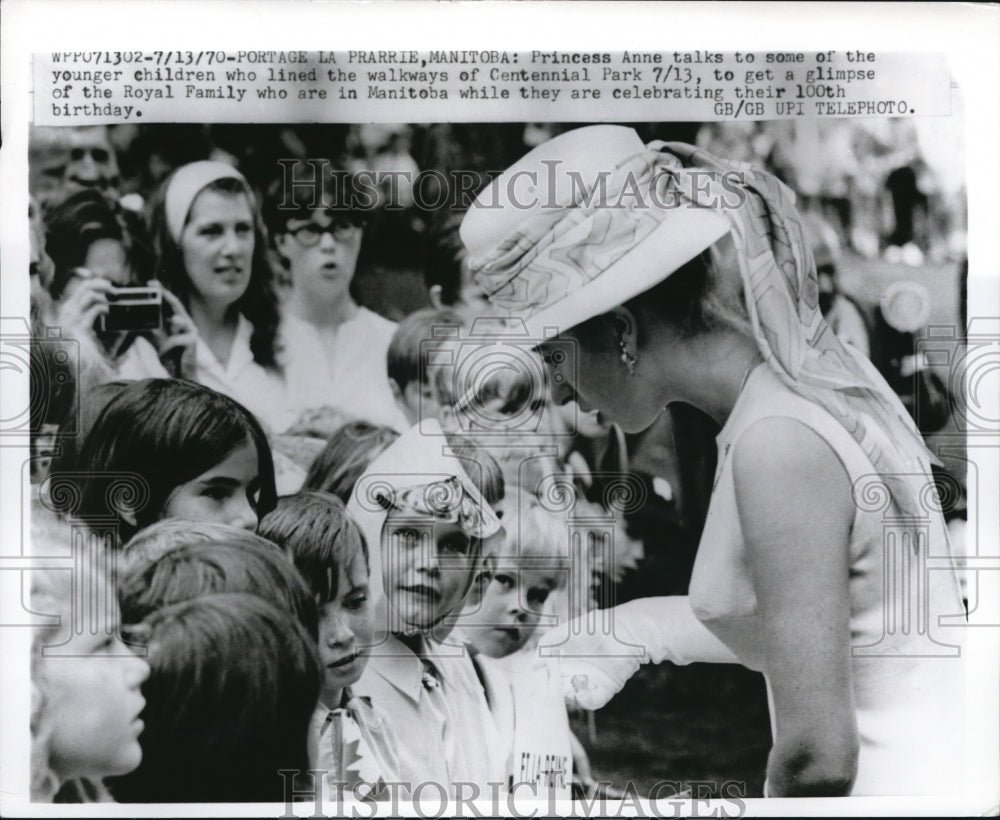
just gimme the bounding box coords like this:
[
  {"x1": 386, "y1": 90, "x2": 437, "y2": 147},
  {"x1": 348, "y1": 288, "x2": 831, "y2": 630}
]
[{"x1": 264, "y1": 165, "x2": 407, "y2": 431}]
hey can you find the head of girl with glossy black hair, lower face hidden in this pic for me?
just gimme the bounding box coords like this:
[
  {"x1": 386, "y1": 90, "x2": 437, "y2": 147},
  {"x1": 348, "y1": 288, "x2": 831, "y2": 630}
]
[{"x1": 48, "y1": 379, "x2": 277, "y2": 542}]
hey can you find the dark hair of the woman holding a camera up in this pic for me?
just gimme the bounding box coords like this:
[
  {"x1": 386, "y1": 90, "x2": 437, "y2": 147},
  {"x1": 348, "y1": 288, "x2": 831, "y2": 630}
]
[{"x1": 45, "y1": 189, "x2": 131, "y2": 300}]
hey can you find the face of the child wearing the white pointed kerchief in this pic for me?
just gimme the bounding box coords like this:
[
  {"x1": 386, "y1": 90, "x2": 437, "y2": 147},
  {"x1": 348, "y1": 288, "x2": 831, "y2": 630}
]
[{"x1": 382, "y1": 510, "x2": 477, "y2": 631}]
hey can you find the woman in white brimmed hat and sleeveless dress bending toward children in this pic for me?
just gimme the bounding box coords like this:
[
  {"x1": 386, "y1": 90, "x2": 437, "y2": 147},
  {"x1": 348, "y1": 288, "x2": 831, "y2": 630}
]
[{"x1": 461, "y1": 126, "x2": 964, "y2": 796}]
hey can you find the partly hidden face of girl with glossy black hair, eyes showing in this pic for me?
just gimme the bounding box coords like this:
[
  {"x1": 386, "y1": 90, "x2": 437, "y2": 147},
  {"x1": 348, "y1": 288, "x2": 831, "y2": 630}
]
[{"x1": 160, "y1": 441, "x2": 260, "y2": 530}]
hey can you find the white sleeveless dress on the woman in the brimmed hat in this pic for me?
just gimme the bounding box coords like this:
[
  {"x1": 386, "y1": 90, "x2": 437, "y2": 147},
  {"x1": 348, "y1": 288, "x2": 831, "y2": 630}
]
[{"x1": 690, "y1": 364, "x2": 965, "y2": 795}]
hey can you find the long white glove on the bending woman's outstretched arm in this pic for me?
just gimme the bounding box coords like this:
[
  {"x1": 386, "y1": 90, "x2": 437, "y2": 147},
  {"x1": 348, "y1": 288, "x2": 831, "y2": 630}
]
[{"x1": 538, "y1": 595, "x2": 739, "y2": 709}]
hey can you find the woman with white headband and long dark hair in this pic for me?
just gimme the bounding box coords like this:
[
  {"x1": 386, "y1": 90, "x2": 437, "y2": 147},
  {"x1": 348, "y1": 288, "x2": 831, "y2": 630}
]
[{"x1": 151, "y1": 156, "x2": 292, "y2": 432}]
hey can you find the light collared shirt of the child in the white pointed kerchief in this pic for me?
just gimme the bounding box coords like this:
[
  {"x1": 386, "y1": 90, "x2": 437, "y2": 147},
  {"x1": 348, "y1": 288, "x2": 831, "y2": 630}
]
[{"x1": 355, "y1": 635, "x2": 506, "y2": 796}]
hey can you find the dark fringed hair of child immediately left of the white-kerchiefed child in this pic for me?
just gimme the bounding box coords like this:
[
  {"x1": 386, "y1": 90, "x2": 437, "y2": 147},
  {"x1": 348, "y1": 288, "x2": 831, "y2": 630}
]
[{"x1": 257, "y1": 491, "x2": 370, "y2": 606}]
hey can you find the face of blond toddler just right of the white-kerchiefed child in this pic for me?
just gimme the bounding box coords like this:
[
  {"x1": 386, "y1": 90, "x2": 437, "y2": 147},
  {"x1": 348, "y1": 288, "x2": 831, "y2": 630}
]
[{"x1": 464, "y1": 569, "x2": 555, "y2": 658}]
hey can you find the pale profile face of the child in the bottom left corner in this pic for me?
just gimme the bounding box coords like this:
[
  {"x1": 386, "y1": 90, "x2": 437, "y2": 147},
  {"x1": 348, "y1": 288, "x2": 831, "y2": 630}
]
[{"x1": 40, "y1": 614, "x2": 149, "y2": 780}]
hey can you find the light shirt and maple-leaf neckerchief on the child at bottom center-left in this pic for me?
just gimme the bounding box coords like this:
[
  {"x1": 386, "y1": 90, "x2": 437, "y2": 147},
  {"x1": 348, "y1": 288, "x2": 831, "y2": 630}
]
[{"x1": 309, "y1": 688, "x2": 399, "y2": 798}]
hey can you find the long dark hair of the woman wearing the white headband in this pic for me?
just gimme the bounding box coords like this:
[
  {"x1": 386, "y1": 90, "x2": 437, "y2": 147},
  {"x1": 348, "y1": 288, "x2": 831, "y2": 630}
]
[{"x1": 149, "y1": 175, "x2": 279, "y2": 368}]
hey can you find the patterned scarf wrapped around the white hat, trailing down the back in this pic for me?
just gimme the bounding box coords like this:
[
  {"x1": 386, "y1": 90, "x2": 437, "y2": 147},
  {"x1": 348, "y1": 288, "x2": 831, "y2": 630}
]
[{"x1": 471, "y1": 142, "x2": 936, "y2": 515}]
